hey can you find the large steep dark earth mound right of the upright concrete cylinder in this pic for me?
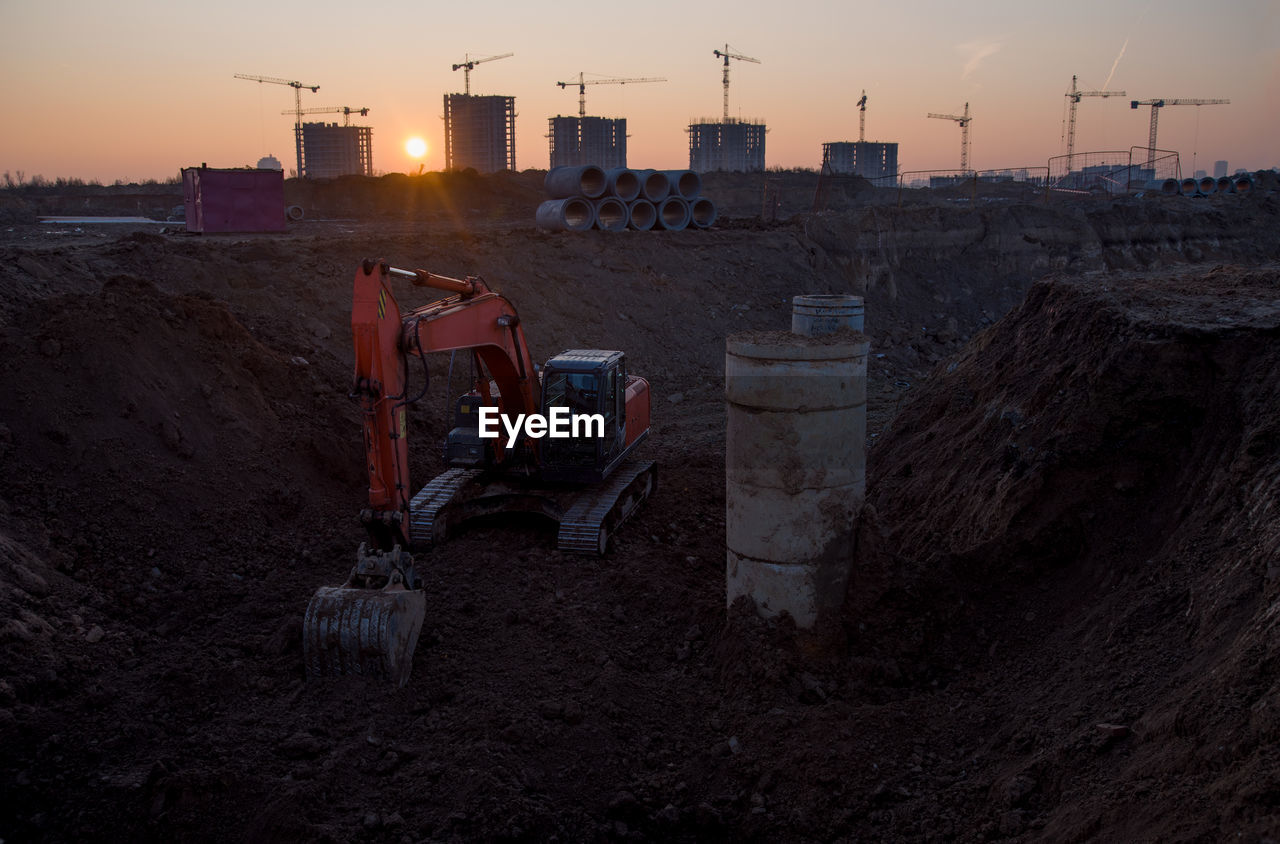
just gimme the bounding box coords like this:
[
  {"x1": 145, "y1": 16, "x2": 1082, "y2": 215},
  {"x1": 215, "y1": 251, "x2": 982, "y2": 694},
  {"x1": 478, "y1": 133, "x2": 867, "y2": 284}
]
[{"x1": 852, "y1": 268, "x2": 1280, "y2": 839}]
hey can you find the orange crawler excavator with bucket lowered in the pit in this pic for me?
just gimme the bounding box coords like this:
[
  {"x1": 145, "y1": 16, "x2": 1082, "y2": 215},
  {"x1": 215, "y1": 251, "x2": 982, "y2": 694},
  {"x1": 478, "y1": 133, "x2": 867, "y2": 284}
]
[{"x1": 303, "y1": 260, "x2": 657, "y2": 685}]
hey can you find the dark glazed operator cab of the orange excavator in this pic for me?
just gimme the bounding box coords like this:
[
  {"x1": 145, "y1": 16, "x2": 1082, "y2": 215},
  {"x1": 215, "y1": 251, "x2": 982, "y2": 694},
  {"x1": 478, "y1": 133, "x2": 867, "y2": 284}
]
[{"x1": 538, "y1": 350, "x2": 649, "y2": 483}]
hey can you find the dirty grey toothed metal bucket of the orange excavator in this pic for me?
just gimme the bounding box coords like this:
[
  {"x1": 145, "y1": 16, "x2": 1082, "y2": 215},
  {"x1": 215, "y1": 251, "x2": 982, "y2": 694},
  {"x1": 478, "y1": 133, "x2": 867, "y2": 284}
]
[{"x1": 302, "y1": 546, "x2": 426, "y2": 686}]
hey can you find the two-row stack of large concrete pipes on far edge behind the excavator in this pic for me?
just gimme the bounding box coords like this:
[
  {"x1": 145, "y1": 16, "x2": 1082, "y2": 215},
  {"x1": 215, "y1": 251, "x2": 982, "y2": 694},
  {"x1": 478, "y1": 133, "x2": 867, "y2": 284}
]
[{"x1": 536, "y1": 164, "x2": 717, "y2": 232}]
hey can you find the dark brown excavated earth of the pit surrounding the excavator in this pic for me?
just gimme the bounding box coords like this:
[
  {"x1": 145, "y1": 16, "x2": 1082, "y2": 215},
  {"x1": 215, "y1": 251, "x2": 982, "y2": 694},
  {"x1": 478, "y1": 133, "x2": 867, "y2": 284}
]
[{"x1": 0, "y1": 181, "x2": 1280, "y2": 841}]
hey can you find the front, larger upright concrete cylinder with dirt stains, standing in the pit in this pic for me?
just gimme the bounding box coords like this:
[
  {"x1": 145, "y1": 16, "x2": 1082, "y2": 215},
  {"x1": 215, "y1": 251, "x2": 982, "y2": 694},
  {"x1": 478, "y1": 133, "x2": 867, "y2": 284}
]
[{"x1": 724, "y1": 332, "x2": 868, "y2": 629}]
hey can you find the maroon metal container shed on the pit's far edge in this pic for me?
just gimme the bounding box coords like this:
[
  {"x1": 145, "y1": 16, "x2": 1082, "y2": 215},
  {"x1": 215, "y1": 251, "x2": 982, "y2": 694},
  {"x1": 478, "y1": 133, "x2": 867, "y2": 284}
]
[{"x1": 182, "y1": 166, "x2": 284, "y2": 232}]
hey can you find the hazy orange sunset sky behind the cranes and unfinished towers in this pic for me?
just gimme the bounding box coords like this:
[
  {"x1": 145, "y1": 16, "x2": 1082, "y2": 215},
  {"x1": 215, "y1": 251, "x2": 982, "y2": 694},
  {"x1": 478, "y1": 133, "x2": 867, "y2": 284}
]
[{"x1": 0, "y1": 0, "x2": 1280, "y2": 182}]
